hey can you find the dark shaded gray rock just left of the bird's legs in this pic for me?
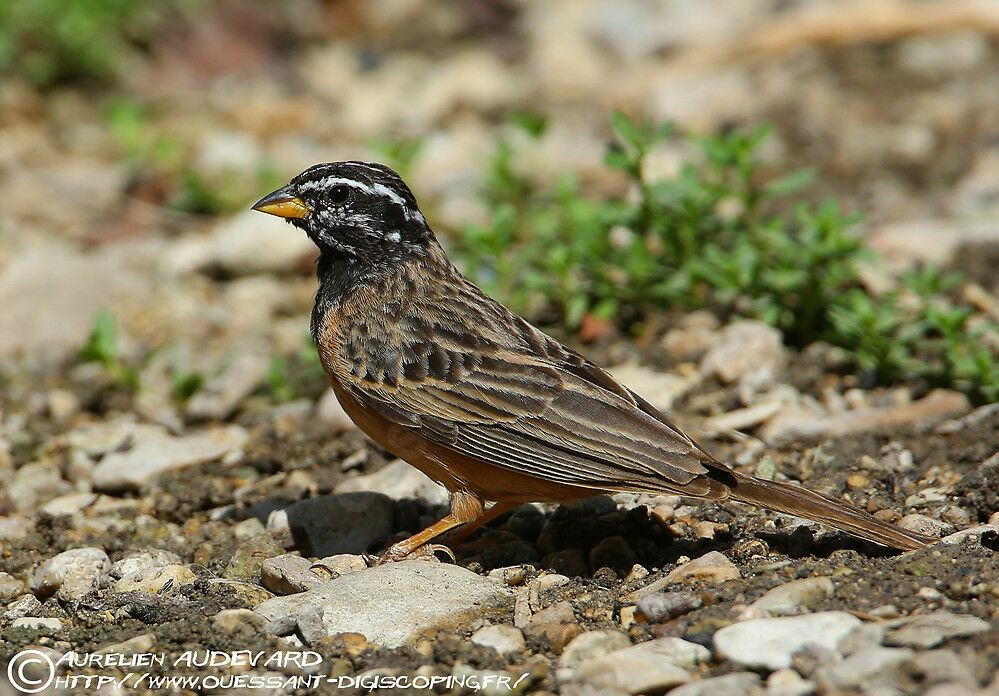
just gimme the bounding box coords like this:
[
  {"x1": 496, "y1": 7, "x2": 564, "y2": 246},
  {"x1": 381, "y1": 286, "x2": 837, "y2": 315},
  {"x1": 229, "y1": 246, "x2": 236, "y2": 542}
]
[{"x1": 267, "y1": 492, "x2": 395, "y2": 557}]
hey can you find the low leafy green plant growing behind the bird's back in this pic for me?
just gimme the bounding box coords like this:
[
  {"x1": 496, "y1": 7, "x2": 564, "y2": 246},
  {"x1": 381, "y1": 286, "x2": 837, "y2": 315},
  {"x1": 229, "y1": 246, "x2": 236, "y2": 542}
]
[{"x1": 455, "y1": 113, "x2": 999, "y2": 400}]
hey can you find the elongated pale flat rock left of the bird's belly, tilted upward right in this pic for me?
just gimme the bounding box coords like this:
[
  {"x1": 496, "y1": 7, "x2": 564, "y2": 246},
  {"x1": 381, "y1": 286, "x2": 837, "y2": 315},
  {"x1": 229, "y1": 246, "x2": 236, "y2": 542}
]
[{"x1": 94, "y1": 425, "x2": 249, "y2": 492}]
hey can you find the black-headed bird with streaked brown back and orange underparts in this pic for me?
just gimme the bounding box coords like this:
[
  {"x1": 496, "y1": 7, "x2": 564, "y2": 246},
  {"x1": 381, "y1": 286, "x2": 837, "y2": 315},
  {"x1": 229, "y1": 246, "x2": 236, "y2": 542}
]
[{"x1": 252, "y1": 161, "x2": 935, "y2": 562}]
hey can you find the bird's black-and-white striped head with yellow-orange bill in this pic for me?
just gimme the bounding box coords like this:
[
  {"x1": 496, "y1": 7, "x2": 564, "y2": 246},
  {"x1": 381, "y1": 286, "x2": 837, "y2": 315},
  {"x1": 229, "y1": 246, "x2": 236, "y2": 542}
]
[{"x1": 253, "y1": 162, "x2": 432, "y2": 263}]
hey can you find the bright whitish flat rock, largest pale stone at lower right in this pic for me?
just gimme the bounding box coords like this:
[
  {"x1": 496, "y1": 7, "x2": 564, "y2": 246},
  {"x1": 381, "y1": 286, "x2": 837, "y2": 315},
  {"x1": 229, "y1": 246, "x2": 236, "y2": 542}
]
[{"x1": 714, "y1": 611, "x2": 860, "y2": 670}]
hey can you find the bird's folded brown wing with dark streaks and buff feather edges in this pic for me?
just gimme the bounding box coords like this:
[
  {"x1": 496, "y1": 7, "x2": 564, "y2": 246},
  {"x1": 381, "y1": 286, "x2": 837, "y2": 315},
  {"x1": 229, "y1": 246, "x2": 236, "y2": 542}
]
[{"x1": 340, "y1": 327, "x2": 716, "y2": 496}]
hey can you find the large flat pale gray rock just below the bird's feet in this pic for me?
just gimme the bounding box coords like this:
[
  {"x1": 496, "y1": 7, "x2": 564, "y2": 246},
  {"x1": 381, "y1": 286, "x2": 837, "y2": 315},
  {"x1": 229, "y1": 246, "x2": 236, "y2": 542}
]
[{"x1": 256, "y1": 560, "x2": 514, "y2": 647}]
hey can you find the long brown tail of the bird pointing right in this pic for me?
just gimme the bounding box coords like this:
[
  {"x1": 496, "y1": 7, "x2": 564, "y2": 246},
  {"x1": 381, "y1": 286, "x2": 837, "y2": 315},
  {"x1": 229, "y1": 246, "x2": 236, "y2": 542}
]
[{"x1": 713, "y1": 467, "x2": 937, "y2": 551}]
